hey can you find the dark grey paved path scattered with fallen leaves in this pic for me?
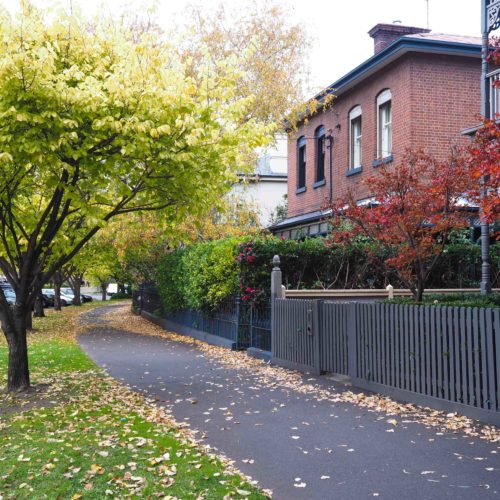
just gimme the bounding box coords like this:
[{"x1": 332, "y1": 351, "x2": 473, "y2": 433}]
[{"x1": 78, "y1": 306, "x2": 500, "y2": 500}]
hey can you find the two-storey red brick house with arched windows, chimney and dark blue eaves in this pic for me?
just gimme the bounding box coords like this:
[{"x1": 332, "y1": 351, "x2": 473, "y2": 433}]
[{"x1": 270, "y1": 24, "x2": 481, "y2": 238}]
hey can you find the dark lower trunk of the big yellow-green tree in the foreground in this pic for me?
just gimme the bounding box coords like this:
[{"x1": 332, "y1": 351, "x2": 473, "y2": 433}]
[{"x1": 2, "y1": 307, "x2": 30, "y2": 392}]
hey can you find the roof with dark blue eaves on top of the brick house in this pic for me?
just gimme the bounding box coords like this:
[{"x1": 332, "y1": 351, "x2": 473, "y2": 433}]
[{"x1": 315, "y1": 33, "x2": 481, "y2": 101}]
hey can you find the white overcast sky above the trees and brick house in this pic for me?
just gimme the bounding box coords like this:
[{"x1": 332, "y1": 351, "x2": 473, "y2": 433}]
[{"x1": 0, "y1": 0, "x2": 481, "y2": 91}]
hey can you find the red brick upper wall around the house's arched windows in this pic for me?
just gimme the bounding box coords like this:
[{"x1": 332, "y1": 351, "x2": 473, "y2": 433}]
[{"x1": 288, "y1": 54, "x2": 481, "y2": 217}]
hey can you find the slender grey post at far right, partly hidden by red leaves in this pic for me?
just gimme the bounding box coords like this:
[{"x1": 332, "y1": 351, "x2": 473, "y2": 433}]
[{"x1": 480, "y1": 0, "x2": 500, "y2": 295}]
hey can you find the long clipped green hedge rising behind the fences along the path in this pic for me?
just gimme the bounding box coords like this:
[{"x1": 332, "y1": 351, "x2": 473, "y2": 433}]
[{"x1": 156, "y1": 236, "x2": 500, "y2": 311}]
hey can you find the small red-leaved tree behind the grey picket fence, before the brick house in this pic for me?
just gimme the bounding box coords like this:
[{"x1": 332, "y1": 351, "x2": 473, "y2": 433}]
[{"x1": 330, "y1": 151, "x2": 471, "y2": 301}]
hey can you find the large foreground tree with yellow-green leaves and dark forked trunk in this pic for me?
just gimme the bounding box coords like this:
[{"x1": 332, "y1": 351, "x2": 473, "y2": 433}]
[{"x1": 0, "y1": 2, "x2": 271, "y2": 391}]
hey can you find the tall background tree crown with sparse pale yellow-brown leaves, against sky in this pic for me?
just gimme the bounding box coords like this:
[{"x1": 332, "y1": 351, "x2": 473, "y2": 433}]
[{"x1": 185, "y1": 0, "x2": 311, "y2": 124}]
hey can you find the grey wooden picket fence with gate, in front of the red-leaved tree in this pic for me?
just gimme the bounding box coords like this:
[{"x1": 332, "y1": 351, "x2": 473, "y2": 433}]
[{"x1": 272, "y1": 256, "x2": 500, "y2": 425}]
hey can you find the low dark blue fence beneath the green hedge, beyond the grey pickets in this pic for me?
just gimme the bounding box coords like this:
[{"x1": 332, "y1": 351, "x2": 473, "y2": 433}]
[{"x1": 133, "y1": 284, "x2": 271, "y2": 351}]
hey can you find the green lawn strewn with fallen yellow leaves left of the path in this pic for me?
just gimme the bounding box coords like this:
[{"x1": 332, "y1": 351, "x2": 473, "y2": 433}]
[{"x1": 0, "y1": 304, "x2": 266, "y2": 499}]
